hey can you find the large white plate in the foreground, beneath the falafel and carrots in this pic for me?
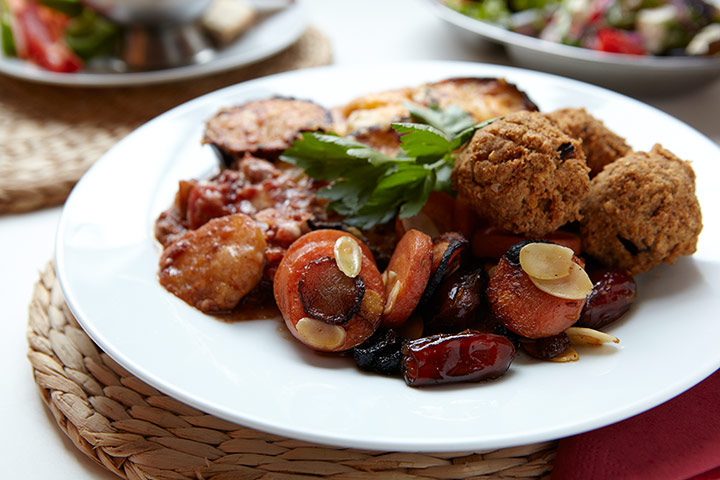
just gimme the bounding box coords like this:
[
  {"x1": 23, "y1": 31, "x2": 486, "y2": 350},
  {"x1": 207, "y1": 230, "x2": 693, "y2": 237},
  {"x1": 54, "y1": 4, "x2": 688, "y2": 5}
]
[{"x1": 56, "y1": 62, "x2": 720, "y2": 451}]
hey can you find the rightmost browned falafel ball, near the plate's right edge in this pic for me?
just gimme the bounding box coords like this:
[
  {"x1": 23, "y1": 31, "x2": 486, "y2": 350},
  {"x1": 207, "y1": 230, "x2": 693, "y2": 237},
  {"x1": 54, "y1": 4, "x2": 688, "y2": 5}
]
[{"x1": 580, "y1": 144, "x2": 702, "y2": 275}]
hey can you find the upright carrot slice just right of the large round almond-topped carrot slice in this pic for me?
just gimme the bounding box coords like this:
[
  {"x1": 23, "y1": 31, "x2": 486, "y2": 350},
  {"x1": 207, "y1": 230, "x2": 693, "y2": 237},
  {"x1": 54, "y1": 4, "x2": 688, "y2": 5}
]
[{"x1": 382, "y1": 230, "x2": 432, "y2": 328}]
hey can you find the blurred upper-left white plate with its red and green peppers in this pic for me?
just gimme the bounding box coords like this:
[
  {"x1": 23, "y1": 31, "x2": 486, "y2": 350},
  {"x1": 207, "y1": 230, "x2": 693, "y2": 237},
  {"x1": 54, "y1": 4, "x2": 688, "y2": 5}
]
[{"x1": 0, "y1": 0, "x2": 308, "y2": 86}]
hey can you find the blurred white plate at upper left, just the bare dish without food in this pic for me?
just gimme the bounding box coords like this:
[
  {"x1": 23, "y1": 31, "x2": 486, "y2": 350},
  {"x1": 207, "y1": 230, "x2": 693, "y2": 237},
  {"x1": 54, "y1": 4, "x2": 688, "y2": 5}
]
[{"x1": 0, "y1": 2, "x2": 308, "y2": 87}]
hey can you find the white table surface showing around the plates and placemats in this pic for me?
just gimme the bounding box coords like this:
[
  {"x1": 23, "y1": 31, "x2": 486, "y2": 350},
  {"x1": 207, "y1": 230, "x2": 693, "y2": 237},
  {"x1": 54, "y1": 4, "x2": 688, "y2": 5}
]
[{"x1": 0, "y1": 0, "x2": 720, "y2": 480}]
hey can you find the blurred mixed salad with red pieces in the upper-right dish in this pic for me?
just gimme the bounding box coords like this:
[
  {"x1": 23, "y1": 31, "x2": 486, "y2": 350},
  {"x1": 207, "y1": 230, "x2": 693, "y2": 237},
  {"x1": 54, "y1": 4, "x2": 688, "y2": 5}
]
[{"x1": 444, "y1": 0, "x2": 720, "y2": 56}]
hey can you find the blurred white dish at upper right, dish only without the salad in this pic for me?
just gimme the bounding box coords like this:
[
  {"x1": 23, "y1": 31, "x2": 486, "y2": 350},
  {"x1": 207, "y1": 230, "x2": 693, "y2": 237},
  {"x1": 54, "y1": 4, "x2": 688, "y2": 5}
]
[{"x1": 426, "y1": 0, "x2": 720, "y2": 94}]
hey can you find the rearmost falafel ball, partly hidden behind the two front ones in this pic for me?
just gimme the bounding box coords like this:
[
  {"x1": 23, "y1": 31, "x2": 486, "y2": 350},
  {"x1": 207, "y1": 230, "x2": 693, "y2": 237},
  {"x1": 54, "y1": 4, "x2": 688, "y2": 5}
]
[{"x1": 548, "y1": 108, "x2": 632, "y2": 178}]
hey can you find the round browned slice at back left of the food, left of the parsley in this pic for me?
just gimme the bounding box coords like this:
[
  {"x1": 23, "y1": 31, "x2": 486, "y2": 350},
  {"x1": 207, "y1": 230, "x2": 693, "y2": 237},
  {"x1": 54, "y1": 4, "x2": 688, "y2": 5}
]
[{"x1": 203, "y1": 97, "x2": 332, "y2": 165}]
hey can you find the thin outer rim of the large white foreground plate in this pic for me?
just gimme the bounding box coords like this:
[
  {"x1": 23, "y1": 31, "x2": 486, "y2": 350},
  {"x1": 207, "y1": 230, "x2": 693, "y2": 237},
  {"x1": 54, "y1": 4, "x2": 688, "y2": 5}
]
[{"x1": 55, "y1": 60, "x2": 720, "y2": 452}]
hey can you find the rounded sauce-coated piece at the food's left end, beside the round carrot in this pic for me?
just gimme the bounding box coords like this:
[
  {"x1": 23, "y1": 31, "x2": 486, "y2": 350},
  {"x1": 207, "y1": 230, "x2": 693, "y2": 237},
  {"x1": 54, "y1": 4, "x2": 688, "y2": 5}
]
[{"x1": 159, "y1": 213, "x2": 265, "y2": 313}]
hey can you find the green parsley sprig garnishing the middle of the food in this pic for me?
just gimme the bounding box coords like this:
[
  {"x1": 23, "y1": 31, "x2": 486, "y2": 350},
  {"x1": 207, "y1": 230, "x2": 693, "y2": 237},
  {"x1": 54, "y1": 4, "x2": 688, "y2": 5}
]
[{"x1": 280, "y1": 105, "x2": 492, "y2": 229}]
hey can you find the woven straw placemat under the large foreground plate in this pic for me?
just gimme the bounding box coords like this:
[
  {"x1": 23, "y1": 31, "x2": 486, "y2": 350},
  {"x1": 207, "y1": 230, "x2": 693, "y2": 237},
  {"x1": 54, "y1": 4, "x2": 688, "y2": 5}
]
[{"x1": 27, "y1": 265, "x2": 557, "y2": 480}]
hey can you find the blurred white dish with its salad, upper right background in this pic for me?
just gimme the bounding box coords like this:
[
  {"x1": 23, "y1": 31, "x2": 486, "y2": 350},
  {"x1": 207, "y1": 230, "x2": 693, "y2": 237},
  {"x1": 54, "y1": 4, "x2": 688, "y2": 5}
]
[{"x1": 427, "y1": 0, "x2": 720, "y2": 94}]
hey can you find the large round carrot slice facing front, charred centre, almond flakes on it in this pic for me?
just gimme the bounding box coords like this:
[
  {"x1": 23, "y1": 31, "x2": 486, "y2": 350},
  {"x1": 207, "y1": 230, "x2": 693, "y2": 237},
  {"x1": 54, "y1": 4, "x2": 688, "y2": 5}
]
[{"x1": 273, "y1": 230, "x2": 385, "y2": 352}]
